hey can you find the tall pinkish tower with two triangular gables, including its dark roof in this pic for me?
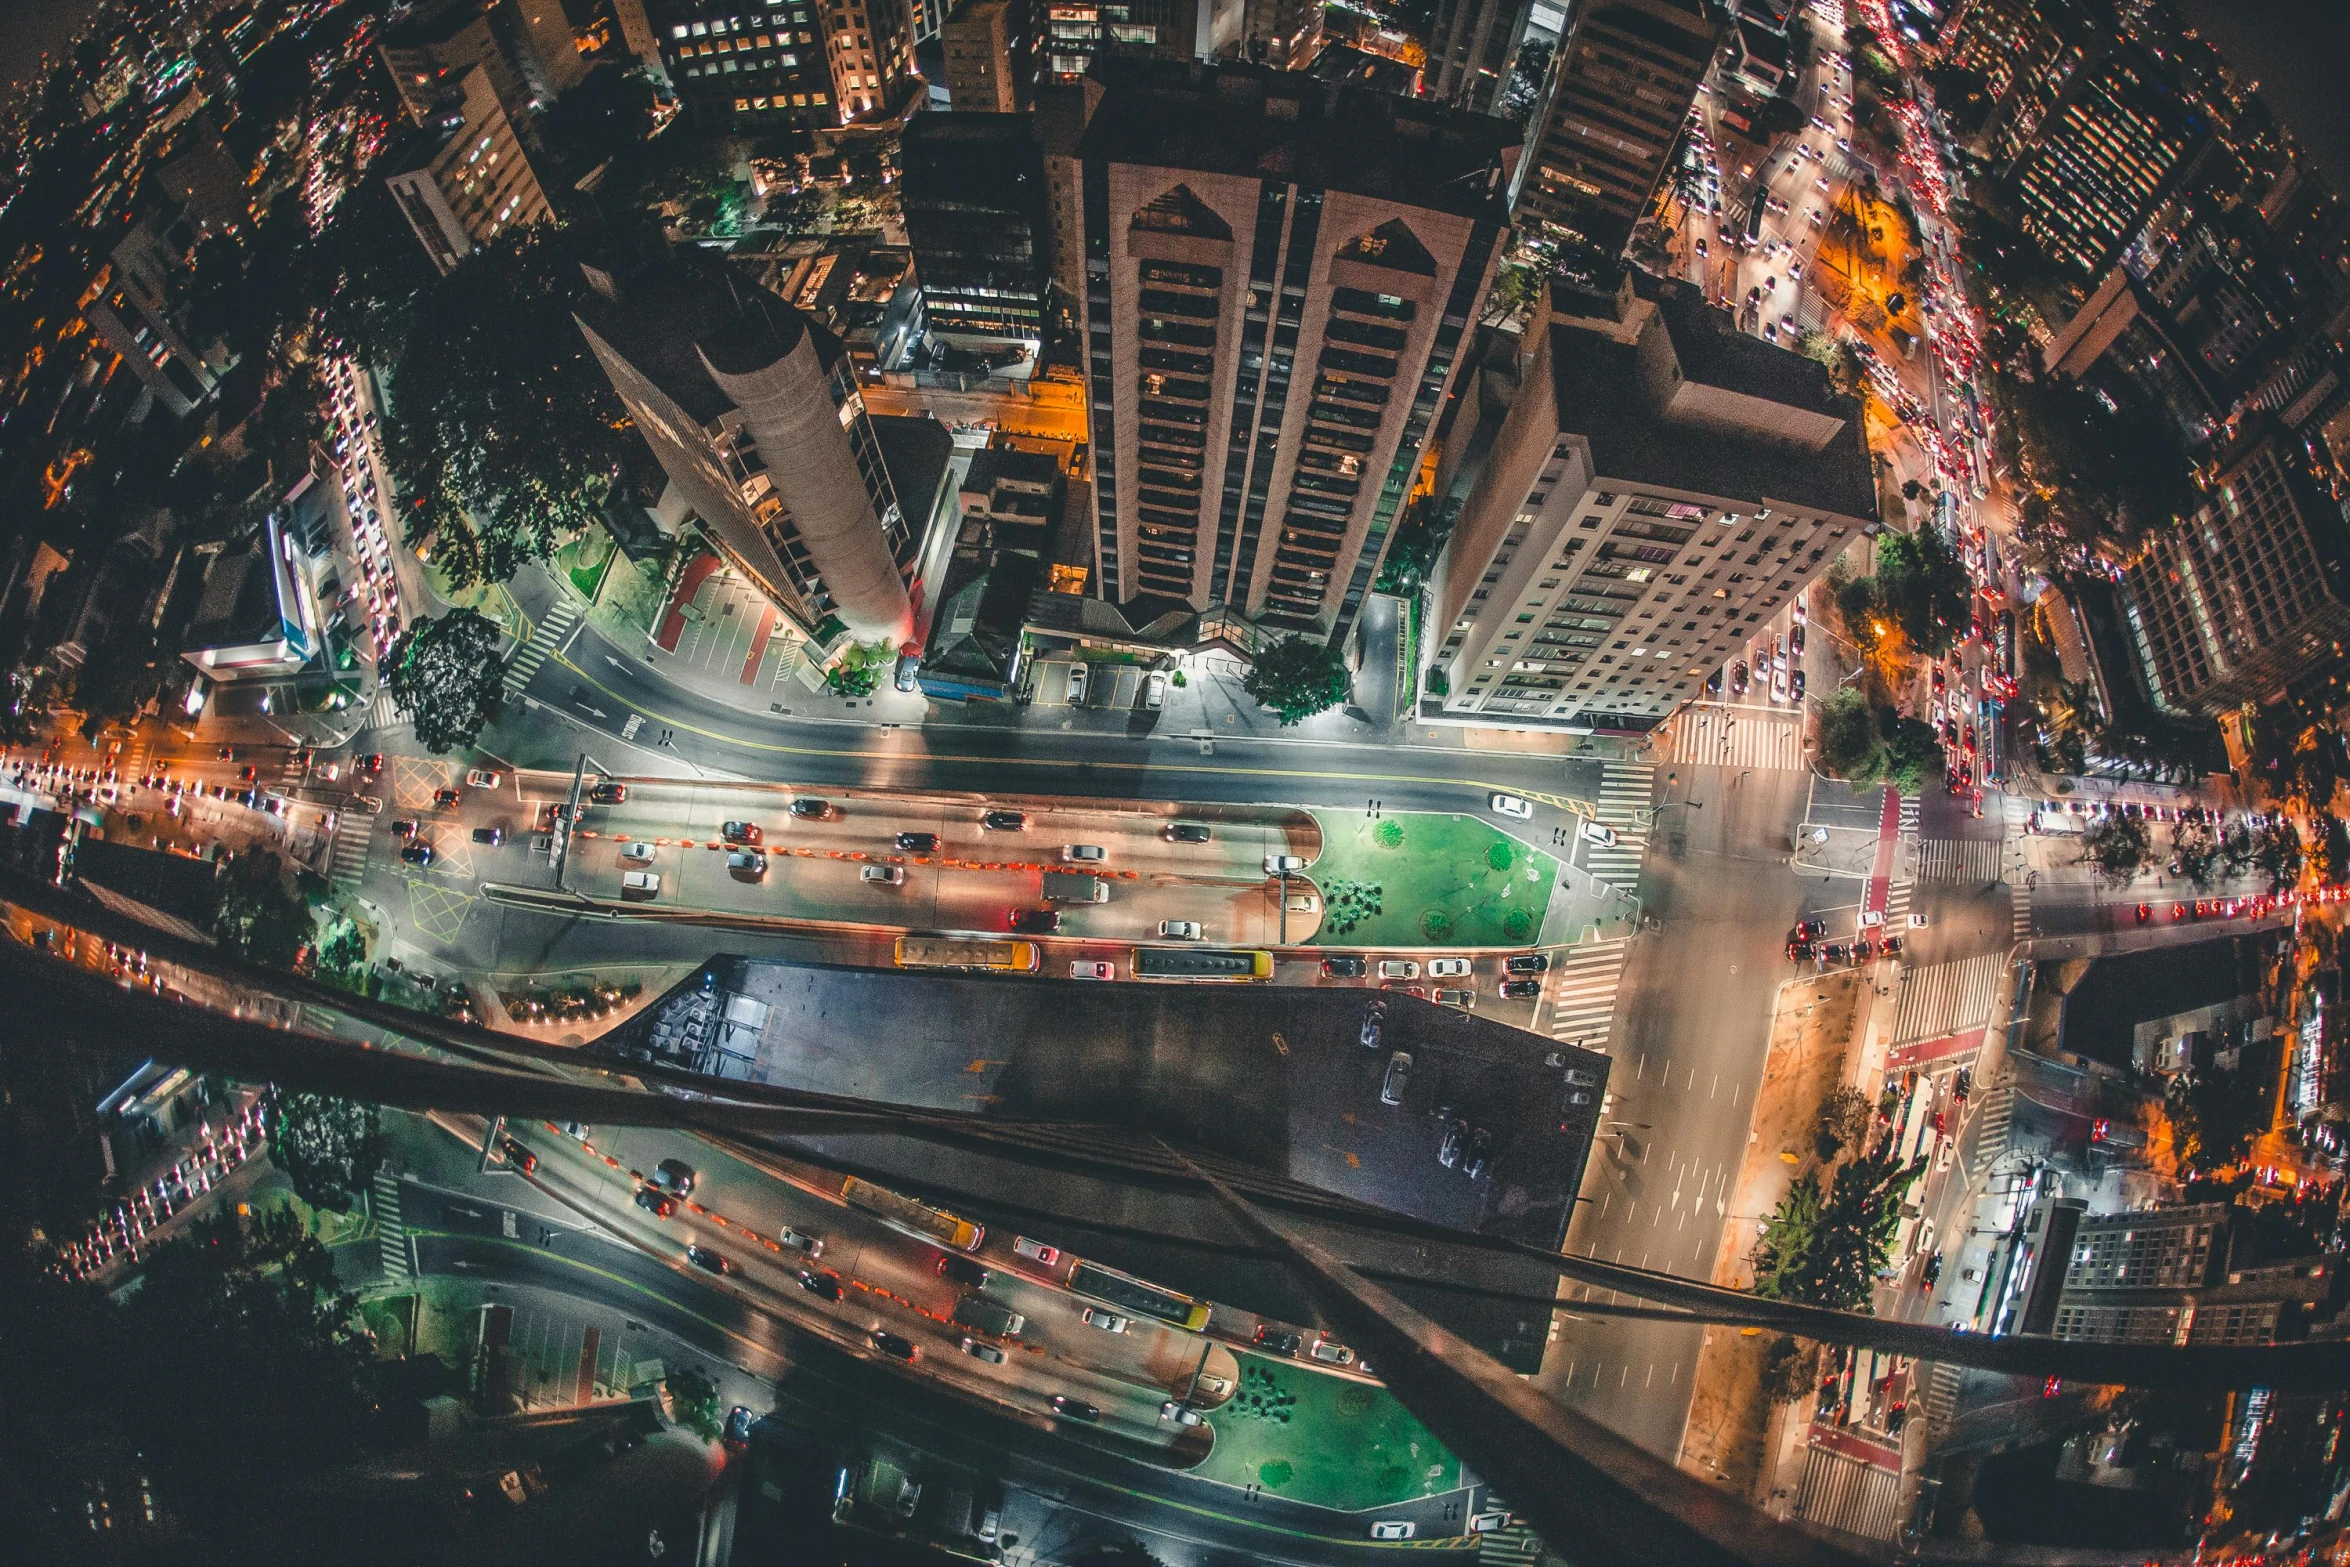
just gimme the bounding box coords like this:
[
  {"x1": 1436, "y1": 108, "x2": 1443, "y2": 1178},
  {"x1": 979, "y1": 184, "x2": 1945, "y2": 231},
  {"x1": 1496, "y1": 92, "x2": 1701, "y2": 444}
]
[{"x1": 1076, "y1": 61, "x2": 1516, "y2": 641}]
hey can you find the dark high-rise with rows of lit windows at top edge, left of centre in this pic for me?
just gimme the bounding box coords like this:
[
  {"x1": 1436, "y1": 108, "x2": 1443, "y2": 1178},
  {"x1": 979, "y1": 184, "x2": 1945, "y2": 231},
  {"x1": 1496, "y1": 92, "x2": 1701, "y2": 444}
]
[{"x1": 646, "y1": 0, "x2": 917, "y2": 129}]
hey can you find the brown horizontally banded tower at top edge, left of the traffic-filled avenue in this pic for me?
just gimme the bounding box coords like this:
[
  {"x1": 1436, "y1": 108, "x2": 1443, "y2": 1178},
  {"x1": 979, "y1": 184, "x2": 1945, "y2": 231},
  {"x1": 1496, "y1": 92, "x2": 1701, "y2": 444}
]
[{"x1": 1516, "y1": 0, "x2": 1723, "y2": 258}]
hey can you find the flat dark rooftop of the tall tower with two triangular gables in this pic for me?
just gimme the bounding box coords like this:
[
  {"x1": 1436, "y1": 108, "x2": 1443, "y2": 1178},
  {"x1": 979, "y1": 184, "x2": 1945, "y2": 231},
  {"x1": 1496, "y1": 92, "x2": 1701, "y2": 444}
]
[{"x1": 1079, "y1": 56, "x2": 1523, "y2": 223}]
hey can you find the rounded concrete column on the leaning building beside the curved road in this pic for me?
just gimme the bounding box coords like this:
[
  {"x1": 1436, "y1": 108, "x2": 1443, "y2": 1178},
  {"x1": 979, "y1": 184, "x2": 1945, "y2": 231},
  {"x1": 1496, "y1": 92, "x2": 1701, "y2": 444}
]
[{"x1": 698, "y1": 328, "x2": 914, "y2": 646}]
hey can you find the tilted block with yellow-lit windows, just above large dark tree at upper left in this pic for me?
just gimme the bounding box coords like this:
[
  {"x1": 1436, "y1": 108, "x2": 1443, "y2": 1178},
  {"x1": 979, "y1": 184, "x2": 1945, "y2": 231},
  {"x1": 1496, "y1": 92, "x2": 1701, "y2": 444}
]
[{"x1": 385, "y1": 66, "x2": 555, "y2": 275}]
